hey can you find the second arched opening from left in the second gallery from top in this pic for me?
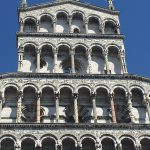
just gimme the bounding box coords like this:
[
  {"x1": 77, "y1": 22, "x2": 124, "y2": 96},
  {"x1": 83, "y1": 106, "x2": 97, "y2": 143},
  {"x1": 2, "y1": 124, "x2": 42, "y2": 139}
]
[{"x1": 40, "y1": 45, "x2": 54, "y2": 73}]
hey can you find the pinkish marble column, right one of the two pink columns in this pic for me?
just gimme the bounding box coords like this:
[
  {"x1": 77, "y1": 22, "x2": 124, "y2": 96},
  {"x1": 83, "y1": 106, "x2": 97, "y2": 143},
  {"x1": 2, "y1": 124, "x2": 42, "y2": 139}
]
[{"x1": 110, "y1": 93, "x2": 117, "y2": 123}]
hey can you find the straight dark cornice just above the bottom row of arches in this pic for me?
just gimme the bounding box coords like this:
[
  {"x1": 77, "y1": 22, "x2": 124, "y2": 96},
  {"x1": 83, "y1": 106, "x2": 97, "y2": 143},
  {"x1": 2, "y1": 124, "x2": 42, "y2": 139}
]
[{"x1": 0, "y1": 123, "x2": 150, "y2": 130}]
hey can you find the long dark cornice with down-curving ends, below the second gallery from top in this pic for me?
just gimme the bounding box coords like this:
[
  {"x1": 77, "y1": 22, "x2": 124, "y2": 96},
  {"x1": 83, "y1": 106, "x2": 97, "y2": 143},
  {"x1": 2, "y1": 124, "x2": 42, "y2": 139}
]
[{"x1": 0, "y1": 72, "x2": 150, "y2": 83}]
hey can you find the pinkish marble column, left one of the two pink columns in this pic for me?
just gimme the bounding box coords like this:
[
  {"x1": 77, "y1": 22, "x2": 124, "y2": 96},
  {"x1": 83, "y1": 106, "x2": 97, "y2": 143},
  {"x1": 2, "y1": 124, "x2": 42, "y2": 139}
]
[{"x1": 36, "y1": 92, "x2": 41, "y2": 123}]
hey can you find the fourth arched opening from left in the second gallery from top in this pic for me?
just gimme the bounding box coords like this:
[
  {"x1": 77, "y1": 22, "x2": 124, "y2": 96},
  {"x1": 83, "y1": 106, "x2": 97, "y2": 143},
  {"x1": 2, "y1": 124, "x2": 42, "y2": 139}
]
[{"x1": 75, "y1": 45, "x2": 89, "y2": 74}]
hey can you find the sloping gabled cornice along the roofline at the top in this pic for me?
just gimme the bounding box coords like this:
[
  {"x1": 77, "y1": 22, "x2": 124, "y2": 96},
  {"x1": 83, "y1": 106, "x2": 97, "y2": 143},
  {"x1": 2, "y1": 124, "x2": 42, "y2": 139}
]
[{"x1": 18, "y1": 0, "x2": 120, "y2": 15}]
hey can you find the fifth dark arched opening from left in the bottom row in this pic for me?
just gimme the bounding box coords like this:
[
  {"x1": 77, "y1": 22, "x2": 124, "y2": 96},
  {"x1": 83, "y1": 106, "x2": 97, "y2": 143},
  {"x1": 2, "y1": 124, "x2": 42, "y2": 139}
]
[{"x1": 82, "y1": 138, "x2": 96, "y2": 150}]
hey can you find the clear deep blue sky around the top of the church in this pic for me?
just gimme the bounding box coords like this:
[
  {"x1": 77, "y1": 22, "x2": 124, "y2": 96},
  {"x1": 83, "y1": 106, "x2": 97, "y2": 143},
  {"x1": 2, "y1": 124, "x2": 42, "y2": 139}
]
[{"x1": 0, "y1": 0, "x2": 150, "y2": 77}]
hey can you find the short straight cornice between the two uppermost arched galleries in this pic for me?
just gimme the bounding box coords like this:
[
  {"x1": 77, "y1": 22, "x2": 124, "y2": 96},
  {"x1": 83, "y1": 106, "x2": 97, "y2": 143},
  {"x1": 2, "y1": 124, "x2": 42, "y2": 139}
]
[{"x1": 17, "y1": 32, "x2": 125, "y2": 40}]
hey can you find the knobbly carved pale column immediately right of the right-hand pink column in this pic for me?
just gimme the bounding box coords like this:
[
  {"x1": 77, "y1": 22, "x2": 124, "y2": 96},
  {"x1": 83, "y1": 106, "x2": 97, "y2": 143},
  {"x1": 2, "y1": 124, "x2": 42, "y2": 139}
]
[{"x1": 126, "y1": 93, "x2": 135, "y2": 123}]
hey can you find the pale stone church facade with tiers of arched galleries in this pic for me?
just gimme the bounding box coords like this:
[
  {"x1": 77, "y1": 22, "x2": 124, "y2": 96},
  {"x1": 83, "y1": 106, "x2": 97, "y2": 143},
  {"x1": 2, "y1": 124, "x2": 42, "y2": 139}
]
[{"x1": 0, "y1": 0, "x2": 150, "y2": 150}]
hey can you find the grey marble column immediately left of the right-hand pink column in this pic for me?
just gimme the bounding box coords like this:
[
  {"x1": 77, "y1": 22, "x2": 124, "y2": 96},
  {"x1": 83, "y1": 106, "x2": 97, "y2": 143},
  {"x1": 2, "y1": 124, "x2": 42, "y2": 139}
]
[{"x1": 91, "y1": 93, "x2": 97, "y2": 123}]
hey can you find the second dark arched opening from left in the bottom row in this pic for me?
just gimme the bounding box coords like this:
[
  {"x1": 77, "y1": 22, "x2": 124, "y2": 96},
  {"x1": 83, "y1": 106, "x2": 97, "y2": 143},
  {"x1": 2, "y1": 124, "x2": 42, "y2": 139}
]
[{"x1": 21, "y1": 139, "x2": 35, "y2": 150}]
